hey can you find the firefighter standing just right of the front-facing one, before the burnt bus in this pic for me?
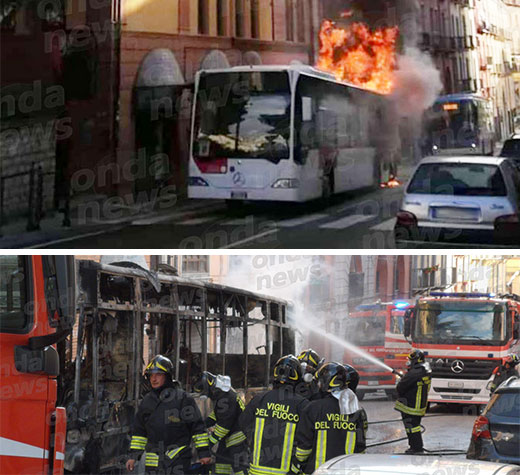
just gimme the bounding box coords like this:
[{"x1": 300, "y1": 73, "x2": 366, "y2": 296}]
[{"x1": 193, "y1": 371, "x2": 248, "y2": 475}]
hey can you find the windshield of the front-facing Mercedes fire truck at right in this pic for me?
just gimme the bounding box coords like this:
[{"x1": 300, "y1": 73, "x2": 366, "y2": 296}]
[{"x1": 415, "y1": 301, "x2": 507, "y2": 345}]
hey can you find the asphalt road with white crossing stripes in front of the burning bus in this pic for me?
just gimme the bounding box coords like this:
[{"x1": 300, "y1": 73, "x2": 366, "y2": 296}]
[{"x1": 41, "y1": 188, "x2": 513, "y2": 249}]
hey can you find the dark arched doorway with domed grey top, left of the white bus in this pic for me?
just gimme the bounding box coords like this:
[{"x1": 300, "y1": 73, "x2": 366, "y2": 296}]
[{"x1": 134, "y1": 49, "x2": 187, "y2": 194}]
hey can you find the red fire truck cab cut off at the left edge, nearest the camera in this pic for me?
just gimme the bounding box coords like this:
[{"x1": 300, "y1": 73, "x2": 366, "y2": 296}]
[{"x1": 0, "y1": 256, "x2": 74, "y2": 474}]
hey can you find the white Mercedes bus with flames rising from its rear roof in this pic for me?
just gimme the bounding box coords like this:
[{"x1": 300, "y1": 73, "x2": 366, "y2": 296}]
[{"x1": 188, "y1": 65, "x2": 387, "y2": 202}]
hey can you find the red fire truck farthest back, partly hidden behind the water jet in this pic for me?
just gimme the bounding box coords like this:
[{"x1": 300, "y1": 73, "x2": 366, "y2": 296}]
[{"x1": 344, "y1": 302, "x2": 411, "y2": 399}]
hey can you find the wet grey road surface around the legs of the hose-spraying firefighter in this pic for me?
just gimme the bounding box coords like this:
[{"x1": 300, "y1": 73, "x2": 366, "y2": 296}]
[{"x1": 361, "y1": 391, "x2": 477, "y2": 458}]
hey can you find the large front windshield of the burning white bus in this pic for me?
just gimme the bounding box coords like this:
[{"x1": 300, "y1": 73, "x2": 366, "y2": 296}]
[{"x1": 193, "y1": 72, "x2": 291, "y2": 160}]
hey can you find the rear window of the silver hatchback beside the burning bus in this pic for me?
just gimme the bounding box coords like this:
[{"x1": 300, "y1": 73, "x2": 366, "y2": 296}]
[{"x1": 408, "y1": 163, "x2": 507, "y2": 196}]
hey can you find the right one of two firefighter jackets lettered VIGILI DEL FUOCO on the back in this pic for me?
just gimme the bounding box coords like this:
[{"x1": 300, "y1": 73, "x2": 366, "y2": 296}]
[{"x1": 292, "y1": 394, "x2": 368, "y2": 473}]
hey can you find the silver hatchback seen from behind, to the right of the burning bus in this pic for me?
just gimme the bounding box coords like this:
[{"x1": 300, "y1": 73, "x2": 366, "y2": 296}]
[{"x1": 394, "y1": 156, "x2": 520, "y2": 244}]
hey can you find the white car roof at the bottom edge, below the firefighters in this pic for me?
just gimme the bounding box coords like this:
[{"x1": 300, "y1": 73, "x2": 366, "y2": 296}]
[{"x1": 314, "y1": 454, "x2": 520, "y2": 475}]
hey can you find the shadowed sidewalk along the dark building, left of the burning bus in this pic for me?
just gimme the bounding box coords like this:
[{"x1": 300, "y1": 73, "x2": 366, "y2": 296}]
[{"x1": 0, "y1": 196, "x2": 226, "y2": 249}]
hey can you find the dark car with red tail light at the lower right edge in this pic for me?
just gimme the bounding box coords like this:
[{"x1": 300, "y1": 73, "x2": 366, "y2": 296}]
[{"x1": 467, "y1": 377, "x2": 520, "y2": 470}]
